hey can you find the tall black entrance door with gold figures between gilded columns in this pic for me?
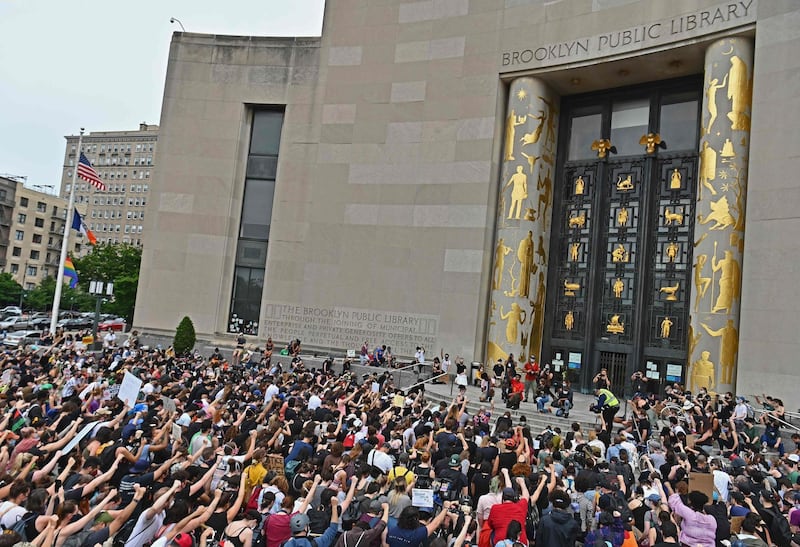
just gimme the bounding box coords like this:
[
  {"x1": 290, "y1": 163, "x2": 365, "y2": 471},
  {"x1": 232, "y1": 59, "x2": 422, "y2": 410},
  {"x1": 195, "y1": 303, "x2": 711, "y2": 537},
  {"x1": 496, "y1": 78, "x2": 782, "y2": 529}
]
[{"x1": 542, "y1": 80, "x2": 701, "y2": 394}]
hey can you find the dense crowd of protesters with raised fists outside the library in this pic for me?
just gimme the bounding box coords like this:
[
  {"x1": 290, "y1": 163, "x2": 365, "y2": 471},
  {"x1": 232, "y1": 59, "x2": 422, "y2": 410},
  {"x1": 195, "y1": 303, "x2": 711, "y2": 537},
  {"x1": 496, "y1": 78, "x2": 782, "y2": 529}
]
[{"x1": 0, "y1": 337, "x2": 800, "y2": 547}]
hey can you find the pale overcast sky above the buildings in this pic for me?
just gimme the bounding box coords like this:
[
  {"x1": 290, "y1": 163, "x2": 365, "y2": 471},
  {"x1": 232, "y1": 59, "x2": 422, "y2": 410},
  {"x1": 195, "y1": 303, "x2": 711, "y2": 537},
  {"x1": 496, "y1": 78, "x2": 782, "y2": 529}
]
[{"x1": 0, "y1": 0, "x2": 324, "y2": 191}]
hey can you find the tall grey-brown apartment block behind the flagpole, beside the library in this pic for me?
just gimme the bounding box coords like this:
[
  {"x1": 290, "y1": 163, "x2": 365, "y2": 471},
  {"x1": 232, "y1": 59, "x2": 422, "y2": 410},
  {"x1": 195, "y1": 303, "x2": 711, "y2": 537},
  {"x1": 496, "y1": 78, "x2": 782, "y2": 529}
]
[{"x1": 61, "y1": 123, "x2": 158, "y2": 254}]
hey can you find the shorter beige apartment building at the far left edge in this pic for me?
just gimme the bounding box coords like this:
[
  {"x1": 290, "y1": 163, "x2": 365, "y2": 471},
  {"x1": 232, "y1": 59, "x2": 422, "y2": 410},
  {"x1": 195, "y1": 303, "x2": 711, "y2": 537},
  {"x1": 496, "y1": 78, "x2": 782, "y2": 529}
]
[{"x1": 0, "y1": 177, "x2": 80, "y2": 290}]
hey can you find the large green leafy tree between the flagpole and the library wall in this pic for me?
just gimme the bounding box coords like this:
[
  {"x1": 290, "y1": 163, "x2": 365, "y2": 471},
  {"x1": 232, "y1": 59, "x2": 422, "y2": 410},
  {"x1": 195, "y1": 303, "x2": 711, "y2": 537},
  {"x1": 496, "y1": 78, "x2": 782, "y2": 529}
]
[{"x1": 72, "y1": 243, "x2": 142, "y2": 323}]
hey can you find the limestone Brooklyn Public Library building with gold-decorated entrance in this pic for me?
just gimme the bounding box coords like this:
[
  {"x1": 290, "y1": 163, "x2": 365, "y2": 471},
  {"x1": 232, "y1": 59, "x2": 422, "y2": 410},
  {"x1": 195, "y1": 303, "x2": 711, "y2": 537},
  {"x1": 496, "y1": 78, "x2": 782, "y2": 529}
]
[{"x1": 134, "y1": 0, "x2": 800, "y2": 398}]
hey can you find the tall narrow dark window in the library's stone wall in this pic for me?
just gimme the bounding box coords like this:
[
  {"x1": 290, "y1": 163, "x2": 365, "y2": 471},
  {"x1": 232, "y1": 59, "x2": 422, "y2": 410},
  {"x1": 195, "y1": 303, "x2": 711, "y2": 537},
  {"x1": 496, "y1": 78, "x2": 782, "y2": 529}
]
[{"x1": 228, "y1": 110, "x2": 283, "y2": 335}]
